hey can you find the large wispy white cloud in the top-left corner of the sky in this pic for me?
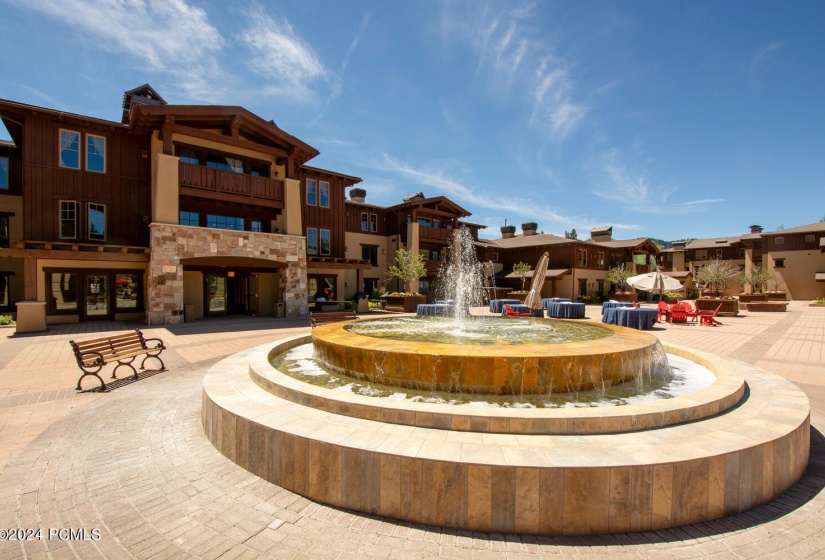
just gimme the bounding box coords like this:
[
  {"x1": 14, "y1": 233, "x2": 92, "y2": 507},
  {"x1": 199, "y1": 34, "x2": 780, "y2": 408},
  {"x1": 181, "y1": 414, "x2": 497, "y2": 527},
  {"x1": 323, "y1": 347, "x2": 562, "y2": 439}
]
[{"x1": 11, "y1": 0, "x2": 224, "y2": 99}]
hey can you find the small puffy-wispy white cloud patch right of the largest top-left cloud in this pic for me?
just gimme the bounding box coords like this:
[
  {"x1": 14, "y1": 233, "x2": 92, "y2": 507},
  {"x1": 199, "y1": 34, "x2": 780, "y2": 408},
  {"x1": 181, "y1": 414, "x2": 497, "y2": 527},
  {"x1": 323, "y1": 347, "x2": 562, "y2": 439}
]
[{"x1": 240, "y1": 5, "x2": 327, "y2": 100}]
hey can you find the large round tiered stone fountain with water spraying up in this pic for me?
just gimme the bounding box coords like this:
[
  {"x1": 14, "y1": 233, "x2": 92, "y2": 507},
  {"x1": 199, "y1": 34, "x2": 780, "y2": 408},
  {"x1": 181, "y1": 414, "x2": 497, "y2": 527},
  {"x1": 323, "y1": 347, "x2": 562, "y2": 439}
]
[{"x1": 202, "y1": 226, "x2": 810, "y2": 534}]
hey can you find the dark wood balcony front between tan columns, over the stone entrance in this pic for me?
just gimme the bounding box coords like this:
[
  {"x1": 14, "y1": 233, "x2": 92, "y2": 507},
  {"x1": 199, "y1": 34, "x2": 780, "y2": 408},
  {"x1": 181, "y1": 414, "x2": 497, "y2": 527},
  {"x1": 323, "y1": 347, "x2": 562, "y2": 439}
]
[{"x1": 179, "y1": 163, "x2": 284, "y2": 208}]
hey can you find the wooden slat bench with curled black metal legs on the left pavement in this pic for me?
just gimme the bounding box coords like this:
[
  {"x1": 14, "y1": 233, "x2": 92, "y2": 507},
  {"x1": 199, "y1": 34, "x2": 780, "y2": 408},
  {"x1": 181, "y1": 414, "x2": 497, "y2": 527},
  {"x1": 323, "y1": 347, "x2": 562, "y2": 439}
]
[{"x1": 69, "y1": 329, "x2": 166, "y2": 391}]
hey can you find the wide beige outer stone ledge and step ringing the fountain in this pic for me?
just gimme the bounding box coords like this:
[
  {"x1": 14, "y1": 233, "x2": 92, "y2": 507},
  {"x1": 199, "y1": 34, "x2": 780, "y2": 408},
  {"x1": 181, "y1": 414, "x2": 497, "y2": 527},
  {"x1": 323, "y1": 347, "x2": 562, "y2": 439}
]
[{"x1": 202, "y1": 337, "x2": 810, "y2": 534}]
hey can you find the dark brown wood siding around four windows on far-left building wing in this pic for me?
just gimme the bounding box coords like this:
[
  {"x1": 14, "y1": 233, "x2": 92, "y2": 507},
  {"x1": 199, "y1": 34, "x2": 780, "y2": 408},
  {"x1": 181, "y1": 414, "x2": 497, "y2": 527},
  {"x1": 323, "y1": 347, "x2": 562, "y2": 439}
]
[{"x1": 23, "y1": 115, "x2": 150, "y2": 247}]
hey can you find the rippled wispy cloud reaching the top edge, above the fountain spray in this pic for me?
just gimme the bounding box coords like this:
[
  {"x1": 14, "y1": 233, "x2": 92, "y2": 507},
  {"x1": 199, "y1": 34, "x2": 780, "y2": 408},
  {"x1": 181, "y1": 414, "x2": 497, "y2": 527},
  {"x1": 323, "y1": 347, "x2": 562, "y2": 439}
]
[{"x1": 442, "y1": 0, "x2": 587, "y2": 141}]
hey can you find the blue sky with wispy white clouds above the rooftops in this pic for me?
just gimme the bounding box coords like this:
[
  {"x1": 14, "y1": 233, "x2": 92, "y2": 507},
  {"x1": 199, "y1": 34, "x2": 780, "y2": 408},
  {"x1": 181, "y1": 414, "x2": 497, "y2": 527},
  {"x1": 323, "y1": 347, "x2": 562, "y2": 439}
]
[{"x1": 0, "y1": 0, "x2": 825, "y2": 240}]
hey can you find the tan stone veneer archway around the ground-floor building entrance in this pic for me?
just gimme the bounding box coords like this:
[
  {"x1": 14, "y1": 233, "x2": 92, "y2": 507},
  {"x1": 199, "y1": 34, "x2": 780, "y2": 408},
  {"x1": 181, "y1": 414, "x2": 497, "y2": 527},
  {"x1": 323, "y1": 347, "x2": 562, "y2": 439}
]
[{"x1": 146, "y1": 224, "x2": 308, "y2": 325}]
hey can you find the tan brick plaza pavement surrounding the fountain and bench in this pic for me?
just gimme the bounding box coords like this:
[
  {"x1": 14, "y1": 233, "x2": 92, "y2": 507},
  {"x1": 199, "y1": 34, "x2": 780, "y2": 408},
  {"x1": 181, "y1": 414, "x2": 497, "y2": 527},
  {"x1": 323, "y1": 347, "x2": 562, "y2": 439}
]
[{"x1": 0, "y1": 302, "x2": 825, "y2": 560}]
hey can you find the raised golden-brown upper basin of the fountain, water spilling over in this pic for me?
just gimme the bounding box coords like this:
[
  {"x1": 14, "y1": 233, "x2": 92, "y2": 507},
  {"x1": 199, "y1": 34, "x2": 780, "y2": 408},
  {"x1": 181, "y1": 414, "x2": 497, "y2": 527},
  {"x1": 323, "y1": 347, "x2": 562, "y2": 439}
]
[{"x1": 312, "y1": 317, "x2": 668, "y2": 394}]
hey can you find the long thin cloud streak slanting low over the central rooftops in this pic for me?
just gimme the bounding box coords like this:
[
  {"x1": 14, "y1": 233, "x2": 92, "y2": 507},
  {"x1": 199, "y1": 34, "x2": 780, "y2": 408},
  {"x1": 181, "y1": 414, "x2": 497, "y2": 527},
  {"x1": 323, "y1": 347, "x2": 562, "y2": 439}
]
[{"x1": 374, "y1": 154, "x2": 593, "y2": 230}]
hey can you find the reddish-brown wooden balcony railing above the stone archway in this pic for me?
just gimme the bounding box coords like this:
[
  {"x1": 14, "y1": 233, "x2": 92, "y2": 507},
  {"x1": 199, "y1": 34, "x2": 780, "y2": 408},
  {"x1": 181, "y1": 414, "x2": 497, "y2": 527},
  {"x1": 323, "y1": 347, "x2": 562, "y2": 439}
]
[{"x1": 180, "y1": 163, "x2": 284, "y2": 202}]
